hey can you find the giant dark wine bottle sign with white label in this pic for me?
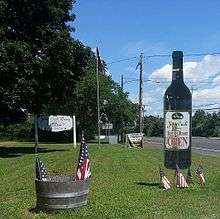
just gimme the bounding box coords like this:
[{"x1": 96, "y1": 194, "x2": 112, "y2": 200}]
[{"x1": 164, "y1": 51, "x2": 192, "y2": 169}]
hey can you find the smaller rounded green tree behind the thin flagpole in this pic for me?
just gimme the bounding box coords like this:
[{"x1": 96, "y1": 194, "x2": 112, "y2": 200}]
[{"x1": 74, "y1": 72, "x2": 136, "y2": 139}]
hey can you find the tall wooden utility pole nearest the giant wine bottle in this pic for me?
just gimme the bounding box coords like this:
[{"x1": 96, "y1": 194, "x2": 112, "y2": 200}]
[{"x1": 138, "y1": 53, "x2": 143, "y2": 134}]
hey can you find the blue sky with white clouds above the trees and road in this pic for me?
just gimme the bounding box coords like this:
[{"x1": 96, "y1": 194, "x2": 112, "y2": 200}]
[{"x1": 72, "y1": 0, "x2": 220, "y2": 116}]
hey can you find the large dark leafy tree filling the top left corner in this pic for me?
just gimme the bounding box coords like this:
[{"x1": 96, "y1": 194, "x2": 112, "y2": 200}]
[{"x1": 0, "y1": 0, "x2": 93, "y2": 121}]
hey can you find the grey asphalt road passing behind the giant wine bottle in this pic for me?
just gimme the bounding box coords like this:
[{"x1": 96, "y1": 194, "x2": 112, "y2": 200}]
[{"x1": 144, "y1": 137, "x2": 220, "y2": 156}]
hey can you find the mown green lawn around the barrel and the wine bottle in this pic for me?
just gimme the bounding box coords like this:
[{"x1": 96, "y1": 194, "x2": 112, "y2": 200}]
[{"x1": 0, "y1": 142, "x2": 220, "y2": 218}]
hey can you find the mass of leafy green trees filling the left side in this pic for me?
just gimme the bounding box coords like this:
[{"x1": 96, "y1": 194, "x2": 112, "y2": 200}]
[{"x1": 0, "y1": 0, "x2": 137, "y2": 138}]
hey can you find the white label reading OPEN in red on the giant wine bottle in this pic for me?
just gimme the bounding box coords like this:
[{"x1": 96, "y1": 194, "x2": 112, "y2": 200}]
[{"x1": 165, "y1": 111, "x2": 190, "y2": 150}]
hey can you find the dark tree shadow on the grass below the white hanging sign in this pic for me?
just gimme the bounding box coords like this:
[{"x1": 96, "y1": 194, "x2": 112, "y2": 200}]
[{"x1": 0, "y1": 147, "x2": 66, "y2": 158}]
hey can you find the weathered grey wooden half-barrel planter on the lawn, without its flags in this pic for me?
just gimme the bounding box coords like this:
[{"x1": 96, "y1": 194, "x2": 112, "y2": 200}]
[{"x1": 35, "y1": 176, "x2": 89, "y2": 210}]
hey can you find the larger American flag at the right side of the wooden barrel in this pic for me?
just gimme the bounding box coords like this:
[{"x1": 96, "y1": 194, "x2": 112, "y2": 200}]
[{"x1": 76, "y1": 140, "x2": 91, "y2": 180}]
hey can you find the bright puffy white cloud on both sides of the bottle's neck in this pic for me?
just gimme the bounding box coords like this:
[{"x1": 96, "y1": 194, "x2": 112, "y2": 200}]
[{"x1": 149, "y1": 55, "x2": 220, "y2": 82}]
